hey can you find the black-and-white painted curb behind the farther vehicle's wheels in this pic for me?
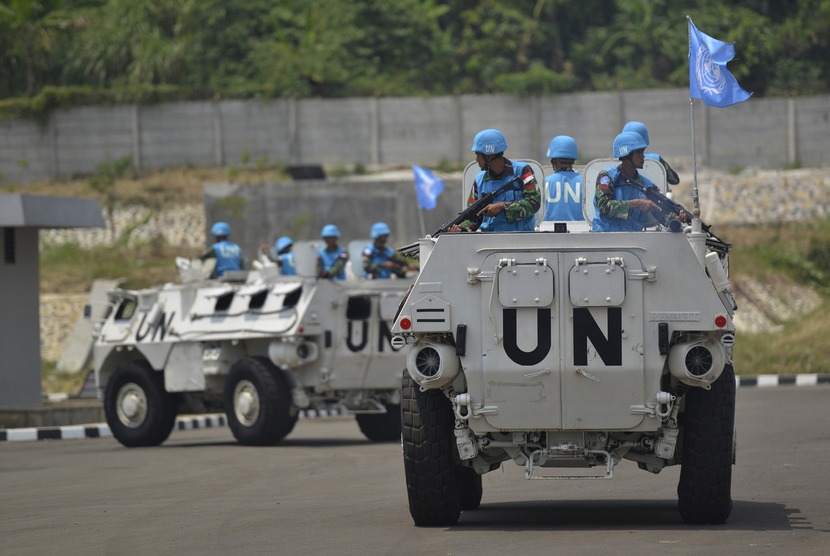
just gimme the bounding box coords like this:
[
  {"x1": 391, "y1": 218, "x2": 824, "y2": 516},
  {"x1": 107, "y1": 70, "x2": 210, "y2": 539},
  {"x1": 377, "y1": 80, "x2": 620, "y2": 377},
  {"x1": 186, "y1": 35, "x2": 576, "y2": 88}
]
[{"x1": 0, "y1": 408, "x2": 350, "y2": 442}]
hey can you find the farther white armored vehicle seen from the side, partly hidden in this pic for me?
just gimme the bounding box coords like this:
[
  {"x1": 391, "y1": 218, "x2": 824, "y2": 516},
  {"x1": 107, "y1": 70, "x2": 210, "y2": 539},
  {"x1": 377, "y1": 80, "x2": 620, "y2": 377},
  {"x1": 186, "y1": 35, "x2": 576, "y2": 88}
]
[{"x1": 94, "y1": 240, "x2": 412, "y2": 446}]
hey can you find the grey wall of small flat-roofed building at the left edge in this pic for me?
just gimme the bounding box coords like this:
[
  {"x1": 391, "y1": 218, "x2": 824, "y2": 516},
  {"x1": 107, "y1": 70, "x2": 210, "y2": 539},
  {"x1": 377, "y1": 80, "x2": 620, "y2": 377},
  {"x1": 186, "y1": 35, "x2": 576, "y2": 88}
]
[{"x1": 0, "y1": 228, "x2": 41, "y2": 407}]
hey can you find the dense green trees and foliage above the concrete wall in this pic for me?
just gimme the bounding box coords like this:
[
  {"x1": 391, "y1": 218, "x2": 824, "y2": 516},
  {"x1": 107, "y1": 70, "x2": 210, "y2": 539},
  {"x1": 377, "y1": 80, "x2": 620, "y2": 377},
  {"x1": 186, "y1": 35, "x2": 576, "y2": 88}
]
[{"x1": 0, "y1": 0, "x2": 830, "y2": 109}]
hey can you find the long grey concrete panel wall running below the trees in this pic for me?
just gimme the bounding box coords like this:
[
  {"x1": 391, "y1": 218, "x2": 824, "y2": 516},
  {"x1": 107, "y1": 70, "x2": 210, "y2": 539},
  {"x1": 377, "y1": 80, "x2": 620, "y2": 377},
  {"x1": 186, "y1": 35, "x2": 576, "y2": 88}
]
[{"x1": 0, "y1": 88, "x2": 830, "y2": 183}]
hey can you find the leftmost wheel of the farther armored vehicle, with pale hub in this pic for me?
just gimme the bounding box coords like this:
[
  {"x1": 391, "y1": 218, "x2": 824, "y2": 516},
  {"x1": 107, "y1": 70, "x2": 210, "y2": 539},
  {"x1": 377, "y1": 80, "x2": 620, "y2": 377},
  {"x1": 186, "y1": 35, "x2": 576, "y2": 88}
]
[{"x1": 104, "y1": 361, "x2": 177, "y2": 448}]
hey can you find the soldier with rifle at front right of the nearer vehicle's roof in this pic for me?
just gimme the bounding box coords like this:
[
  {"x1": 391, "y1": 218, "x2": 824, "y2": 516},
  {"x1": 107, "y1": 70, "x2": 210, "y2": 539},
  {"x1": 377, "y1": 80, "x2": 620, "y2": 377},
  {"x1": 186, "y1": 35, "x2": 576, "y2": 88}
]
[{"x1": 591, "y1": 131, "x2": 690, "y2": 232}]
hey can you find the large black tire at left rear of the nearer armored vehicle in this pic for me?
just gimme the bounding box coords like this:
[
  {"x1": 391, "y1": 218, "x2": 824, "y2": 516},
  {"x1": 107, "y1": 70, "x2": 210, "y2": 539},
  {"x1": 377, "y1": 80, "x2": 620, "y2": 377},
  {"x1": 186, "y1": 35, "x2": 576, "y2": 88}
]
[{"x1": 401, "y1": 372, "x2": 461, "y2": 527}]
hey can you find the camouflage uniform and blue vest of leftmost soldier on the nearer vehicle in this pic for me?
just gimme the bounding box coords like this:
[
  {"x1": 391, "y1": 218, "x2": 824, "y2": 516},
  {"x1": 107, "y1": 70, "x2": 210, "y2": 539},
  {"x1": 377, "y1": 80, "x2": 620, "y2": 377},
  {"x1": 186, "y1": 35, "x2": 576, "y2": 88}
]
[{"x1": 459, "y1": 158, "x2": 542, "y2": 232}]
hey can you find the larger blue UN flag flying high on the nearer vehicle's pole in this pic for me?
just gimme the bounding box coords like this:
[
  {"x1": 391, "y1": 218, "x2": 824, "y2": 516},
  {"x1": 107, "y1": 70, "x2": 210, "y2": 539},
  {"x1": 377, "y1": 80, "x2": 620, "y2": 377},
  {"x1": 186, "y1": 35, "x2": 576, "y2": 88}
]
[{"x1": 689, "y1": 18, "x2": 752, "y2": 108}]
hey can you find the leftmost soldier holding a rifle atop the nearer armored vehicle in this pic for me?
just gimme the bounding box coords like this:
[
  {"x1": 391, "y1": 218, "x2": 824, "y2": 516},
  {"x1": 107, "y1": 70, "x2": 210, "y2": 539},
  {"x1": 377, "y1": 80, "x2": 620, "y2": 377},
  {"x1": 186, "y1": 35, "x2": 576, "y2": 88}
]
[{"x1": 447, "y1": 129, "x2": 542, "y2": 232}]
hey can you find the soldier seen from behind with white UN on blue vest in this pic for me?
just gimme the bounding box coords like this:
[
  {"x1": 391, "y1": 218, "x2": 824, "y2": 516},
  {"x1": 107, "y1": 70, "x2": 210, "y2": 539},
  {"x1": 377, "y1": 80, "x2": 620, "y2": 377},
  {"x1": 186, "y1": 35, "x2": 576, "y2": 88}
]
[{"x1": 545, "y1": 135, "x2": 583, "y2": 222}]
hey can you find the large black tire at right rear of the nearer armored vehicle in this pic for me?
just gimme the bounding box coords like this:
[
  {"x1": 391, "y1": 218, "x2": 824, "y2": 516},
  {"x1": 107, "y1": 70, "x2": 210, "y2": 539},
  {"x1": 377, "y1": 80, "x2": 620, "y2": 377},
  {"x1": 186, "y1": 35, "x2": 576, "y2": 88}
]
[{"x1": 677, "y1": 365, "x2": 735, "y2": 524}]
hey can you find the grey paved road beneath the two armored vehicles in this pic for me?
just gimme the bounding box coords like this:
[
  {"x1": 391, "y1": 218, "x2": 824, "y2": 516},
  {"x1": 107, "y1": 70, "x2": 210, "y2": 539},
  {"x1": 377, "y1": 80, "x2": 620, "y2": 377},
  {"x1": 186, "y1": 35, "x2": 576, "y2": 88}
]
[{"x1": 0, "y1": 385, "x2": 830, "y2": 556}]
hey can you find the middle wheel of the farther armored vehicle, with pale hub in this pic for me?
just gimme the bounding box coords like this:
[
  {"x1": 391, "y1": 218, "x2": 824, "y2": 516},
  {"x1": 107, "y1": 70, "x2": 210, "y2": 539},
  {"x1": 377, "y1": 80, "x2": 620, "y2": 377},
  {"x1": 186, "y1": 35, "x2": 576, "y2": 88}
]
[{"x1": 224, "y1": 357, "x2": 299, "y2": 446}]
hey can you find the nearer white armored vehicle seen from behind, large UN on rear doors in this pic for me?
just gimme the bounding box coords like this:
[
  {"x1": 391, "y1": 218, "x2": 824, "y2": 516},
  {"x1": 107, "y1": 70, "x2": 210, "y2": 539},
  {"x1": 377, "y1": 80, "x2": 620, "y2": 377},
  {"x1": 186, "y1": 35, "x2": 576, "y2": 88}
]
[{"x1": 392, "y1": 156, "x2": 736, "y2": 526}]
